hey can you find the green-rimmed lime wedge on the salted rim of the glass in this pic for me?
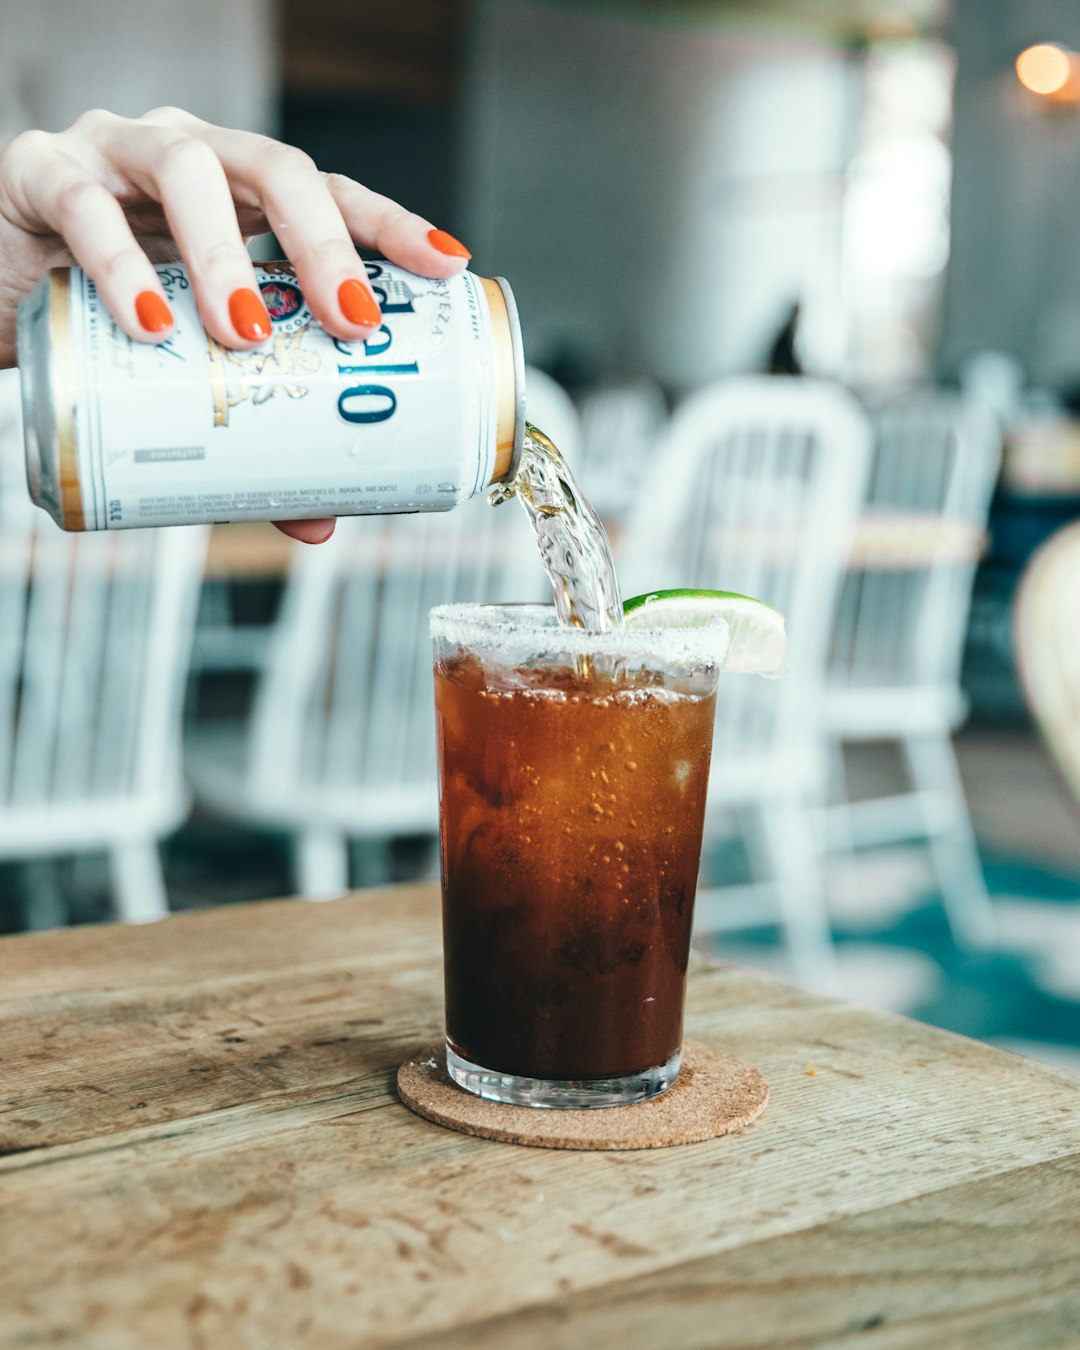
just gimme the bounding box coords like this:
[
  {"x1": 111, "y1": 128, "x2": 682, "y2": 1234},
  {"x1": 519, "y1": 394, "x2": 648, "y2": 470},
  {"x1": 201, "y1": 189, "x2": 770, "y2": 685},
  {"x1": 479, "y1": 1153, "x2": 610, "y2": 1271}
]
[{"x1": 622, "y1": 590, "x2": 787, "y2": 676}]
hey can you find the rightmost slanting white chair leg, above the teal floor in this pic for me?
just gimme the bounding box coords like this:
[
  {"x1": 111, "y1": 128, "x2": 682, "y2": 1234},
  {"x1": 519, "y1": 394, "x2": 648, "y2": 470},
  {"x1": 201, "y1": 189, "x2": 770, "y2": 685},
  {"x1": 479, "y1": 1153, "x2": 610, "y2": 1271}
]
[{"x1": 903, "y1": 734, "x2": 998, "y2": 948}]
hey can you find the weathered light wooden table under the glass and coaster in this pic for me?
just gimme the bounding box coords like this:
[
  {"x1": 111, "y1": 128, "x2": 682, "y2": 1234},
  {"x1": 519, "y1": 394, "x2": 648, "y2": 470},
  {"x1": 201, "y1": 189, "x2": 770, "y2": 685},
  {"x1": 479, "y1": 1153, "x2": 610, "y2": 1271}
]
[{"x1": 0, "y1": 887, "x2": 1080, "y2": 1350}]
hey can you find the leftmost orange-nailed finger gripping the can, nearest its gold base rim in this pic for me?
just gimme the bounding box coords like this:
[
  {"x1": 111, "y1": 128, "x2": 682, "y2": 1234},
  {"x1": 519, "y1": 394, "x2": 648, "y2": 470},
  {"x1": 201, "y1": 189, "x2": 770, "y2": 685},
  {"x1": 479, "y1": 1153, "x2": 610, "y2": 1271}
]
[{"x1": 7, "y1": 138, "x2": 173, "y2": 343}]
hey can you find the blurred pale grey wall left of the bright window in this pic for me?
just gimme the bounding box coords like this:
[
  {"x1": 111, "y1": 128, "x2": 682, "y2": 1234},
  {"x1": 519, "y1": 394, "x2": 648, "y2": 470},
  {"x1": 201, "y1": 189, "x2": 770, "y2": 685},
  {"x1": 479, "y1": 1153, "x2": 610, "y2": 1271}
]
[{"x1": 459, "y1": 0, "x2": 853, "y2": 387}]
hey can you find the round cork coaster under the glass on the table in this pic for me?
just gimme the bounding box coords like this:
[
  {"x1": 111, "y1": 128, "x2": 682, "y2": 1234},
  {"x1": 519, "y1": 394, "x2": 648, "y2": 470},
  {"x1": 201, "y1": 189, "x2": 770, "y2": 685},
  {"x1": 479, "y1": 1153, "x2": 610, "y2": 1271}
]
[{"x1": 397, "y1": 1041, "x2": 768, "y2": 1149}]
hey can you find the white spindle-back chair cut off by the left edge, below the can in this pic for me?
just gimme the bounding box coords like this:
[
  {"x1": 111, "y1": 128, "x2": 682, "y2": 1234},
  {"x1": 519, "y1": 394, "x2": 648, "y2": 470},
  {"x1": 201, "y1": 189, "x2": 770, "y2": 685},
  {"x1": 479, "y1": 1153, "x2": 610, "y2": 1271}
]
[{"x1": 0, "y1": 381, "x2": 207, "y2": 926}]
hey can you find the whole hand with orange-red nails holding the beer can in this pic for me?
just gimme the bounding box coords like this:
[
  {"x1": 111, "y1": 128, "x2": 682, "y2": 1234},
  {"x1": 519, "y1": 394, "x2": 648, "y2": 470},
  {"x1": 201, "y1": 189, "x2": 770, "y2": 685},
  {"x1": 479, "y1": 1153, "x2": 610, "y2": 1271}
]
[{"x1": 0, "y1": 108, "x2": 470, "y2": 543}]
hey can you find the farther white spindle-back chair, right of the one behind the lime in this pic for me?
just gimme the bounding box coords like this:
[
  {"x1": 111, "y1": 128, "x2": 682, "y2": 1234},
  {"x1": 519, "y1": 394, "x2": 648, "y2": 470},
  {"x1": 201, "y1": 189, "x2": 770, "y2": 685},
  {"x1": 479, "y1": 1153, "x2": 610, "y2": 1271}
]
[{"x1": 825, "y1": 393, "x2": 1000, "y2": 946}]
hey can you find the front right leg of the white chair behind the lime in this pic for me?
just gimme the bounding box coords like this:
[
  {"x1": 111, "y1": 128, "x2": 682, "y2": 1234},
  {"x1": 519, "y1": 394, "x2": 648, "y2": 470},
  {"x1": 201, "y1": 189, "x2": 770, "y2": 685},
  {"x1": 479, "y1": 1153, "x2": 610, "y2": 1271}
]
[{"x1": 761, "y1": 797, "x2": 838, "y2": 992}]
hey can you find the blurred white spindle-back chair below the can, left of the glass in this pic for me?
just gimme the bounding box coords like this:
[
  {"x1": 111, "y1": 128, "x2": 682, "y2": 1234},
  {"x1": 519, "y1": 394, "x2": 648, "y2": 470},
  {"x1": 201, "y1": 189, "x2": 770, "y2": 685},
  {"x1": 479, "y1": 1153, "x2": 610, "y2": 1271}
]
[{"x1": 188, "y1": 486, "x2": 551, "y2": 899}]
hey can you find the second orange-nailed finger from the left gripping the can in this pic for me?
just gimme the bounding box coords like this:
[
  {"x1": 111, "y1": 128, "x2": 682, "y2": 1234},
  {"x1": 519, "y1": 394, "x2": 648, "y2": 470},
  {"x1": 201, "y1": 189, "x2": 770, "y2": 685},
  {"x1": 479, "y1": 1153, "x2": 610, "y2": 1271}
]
[{"x1": 103, "y1": 120, "x2": 270, "y2": 348}]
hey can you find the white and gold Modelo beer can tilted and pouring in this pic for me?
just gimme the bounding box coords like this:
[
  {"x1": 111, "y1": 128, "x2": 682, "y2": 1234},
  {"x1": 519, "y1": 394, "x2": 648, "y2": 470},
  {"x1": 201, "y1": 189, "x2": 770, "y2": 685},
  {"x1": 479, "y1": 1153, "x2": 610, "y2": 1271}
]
[{"x1": 19, "y1": 259, "x2": 525, "y2": 529}]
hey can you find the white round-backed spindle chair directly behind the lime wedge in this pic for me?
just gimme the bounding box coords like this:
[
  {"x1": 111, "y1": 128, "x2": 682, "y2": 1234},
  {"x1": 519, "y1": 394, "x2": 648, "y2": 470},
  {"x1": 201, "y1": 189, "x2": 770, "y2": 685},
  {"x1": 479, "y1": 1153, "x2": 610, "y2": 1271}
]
[{"x1": 618, "y1": 377, "x2": 869, "y2": 987}]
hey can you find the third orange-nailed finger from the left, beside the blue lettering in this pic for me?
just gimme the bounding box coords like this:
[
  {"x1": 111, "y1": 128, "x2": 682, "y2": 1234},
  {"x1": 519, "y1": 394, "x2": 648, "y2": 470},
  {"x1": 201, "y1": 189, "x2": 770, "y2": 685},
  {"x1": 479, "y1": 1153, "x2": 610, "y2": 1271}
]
[{"x1": 195, "y1": 127, "x2": 382, "y2": 342}]
